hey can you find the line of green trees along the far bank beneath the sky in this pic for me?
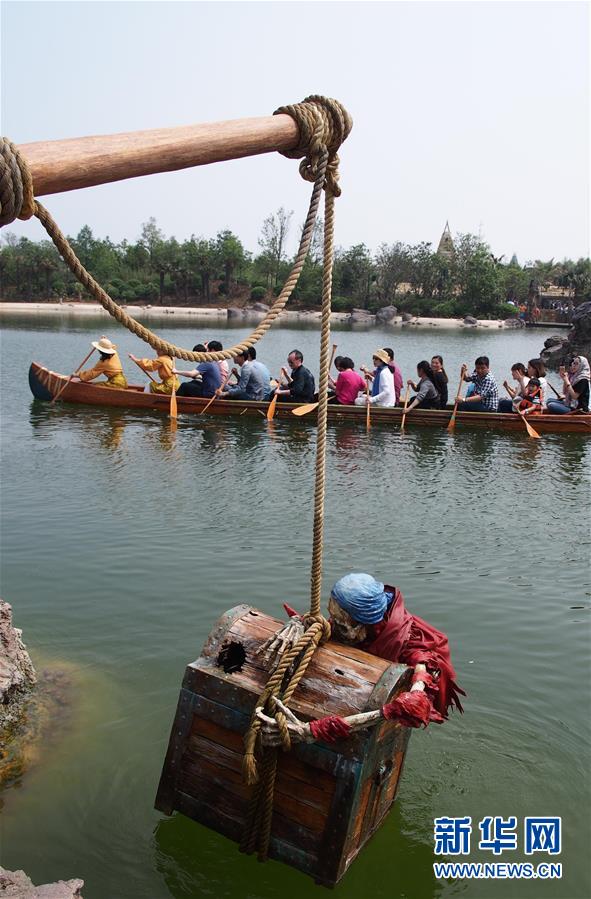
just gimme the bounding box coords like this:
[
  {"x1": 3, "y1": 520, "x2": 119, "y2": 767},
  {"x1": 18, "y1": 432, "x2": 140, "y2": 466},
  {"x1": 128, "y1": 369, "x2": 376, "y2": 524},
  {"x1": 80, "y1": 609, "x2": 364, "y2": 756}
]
[{"x1": 0, "y1": 209, "x2": 591, "y2": 318}]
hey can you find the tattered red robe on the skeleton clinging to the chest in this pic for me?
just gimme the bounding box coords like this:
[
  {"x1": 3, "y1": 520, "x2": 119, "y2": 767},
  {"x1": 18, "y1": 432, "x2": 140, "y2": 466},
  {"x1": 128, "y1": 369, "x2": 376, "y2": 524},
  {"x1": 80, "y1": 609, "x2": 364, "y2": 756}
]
[{"x1": 360, "y1": 584, "x2": 466, "y2": 718}]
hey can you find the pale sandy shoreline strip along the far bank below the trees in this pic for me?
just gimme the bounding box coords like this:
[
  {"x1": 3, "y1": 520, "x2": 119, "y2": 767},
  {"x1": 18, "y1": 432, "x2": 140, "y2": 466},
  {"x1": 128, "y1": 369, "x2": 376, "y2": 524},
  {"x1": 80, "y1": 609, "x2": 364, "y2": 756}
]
[{"x1": 0, "y1": 301, "x2": 523, "y2": 330}]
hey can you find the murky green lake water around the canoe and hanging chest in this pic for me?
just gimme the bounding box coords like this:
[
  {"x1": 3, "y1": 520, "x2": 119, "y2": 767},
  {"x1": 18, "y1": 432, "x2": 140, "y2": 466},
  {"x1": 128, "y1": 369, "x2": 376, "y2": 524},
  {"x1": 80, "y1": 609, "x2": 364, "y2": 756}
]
[{"x1": 0, "y1": 316, "x2": 591, "y2": 899}]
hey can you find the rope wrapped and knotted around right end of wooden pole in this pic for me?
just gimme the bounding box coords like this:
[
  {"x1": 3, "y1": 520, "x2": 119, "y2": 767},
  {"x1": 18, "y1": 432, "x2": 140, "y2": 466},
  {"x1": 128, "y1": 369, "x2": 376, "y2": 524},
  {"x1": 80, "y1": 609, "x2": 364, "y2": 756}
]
[{"x1": 273, "y1": 94, "x2": 353, "y2": 197}]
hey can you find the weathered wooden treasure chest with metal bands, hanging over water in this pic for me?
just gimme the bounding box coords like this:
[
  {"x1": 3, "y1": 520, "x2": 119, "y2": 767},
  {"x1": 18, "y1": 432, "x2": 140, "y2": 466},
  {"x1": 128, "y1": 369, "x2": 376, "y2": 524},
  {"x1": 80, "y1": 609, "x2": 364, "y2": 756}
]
[{"x1": 156, "y1": 605, "x2": 412, "y2": 886}]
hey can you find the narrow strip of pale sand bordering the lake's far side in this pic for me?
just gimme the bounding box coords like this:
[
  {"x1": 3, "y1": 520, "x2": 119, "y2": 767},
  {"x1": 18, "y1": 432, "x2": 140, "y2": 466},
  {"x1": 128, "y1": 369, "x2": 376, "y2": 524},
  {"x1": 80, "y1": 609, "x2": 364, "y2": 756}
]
[{"x1": 0, "y1": 302, "x2": 506, "y2": 330}]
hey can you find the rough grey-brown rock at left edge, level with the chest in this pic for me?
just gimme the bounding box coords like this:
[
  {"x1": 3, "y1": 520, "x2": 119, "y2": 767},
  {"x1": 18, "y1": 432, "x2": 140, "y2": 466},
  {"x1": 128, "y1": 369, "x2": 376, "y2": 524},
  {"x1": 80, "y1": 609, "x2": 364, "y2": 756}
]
[{"x1": 0, "y1": 599, "x2": 36, "y2": 736}]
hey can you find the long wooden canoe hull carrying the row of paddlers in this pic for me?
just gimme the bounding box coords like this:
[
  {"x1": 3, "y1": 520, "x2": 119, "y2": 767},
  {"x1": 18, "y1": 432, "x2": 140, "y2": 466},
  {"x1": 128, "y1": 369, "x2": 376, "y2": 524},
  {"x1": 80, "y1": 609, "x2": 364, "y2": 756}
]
[{"x1": 29, "y1": 362, "x2": 591, "y2": 436}]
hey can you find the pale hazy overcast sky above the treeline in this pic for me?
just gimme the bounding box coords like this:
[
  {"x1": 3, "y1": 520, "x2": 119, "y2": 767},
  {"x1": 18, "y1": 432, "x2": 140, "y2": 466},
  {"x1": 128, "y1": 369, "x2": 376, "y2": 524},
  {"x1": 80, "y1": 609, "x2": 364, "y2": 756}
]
[{"x1": 2, "y1": 0, "x2": 590, "y2": 263}]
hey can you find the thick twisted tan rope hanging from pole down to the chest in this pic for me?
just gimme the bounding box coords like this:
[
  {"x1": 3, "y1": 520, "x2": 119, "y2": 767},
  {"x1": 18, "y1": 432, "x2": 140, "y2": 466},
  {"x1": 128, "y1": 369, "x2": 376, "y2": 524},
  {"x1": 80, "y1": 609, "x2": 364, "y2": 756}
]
[{"x1": 0, "y1": 95, "x2": 353, "y2": 861}]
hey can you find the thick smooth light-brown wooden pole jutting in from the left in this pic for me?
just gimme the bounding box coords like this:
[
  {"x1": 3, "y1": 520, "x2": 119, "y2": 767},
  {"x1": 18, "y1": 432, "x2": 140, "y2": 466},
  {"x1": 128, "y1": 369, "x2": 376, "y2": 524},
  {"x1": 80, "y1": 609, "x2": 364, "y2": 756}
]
[{"x1": 19, "y1": 115, "x2": 299, "y2": 197}]
